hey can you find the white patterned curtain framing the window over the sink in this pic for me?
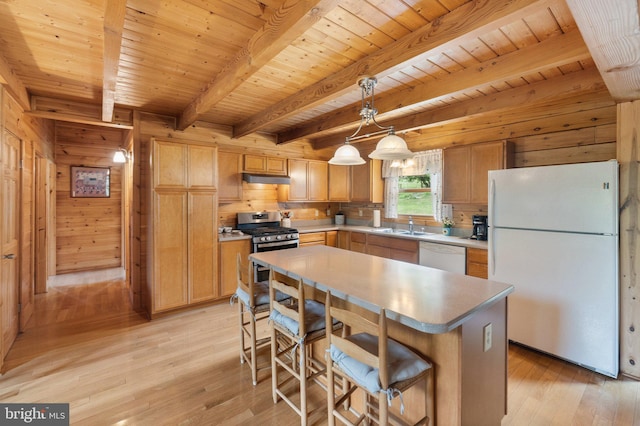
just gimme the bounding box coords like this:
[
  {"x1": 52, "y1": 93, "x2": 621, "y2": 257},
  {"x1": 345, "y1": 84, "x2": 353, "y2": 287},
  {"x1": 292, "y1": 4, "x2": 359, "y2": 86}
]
[{"x1": 382, "y1": 149, "x2": 442, "y2": 222}]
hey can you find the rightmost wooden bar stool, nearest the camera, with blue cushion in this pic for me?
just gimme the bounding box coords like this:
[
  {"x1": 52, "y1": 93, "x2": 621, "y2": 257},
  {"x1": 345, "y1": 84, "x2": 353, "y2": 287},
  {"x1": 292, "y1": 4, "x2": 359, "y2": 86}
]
[{"x1": 325, "y1": 292, "x2": 433, "y2": 426}]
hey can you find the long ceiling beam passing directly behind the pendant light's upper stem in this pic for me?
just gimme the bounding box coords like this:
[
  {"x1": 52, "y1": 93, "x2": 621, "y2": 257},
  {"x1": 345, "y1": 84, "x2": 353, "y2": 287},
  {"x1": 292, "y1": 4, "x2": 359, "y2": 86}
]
[{"x1": 278, "y1": 30, "x2": 589, "y2": 143}]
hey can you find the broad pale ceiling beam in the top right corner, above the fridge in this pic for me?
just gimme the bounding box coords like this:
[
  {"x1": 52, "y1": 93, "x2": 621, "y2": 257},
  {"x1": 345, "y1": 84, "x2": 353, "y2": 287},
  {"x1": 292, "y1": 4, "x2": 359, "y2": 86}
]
[{"x1": 567, "y1": 0, "x2": 640, "y2": 102}]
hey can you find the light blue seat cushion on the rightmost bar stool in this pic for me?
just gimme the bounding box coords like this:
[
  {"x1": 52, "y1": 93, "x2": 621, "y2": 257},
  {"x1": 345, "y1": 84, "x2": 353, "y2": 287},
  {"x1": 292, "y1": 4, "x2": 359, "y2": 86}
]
[{"x1": 330, "y1": 333, "x2": 431, "y2": 393}]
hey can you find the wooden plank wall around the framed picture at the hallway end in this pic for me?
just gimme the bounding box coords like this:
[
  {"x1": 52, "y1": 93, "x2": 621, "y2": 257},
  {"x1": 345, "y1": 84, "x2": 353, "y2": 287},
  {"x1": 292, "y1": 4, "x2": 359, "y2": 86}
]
[{"x1": 55, "y1": 122, "x2": 126, "y2": 274}]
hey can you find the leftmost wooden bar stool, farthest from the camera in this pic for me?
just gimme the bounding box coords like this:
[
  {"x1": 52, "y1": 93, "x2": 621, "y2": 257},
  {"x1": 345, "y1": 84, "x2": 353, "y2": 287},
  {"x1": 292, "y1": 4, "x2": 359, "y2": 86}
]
[{"x1": 232, "y1": 253, "x2": 272, "y2": 386}]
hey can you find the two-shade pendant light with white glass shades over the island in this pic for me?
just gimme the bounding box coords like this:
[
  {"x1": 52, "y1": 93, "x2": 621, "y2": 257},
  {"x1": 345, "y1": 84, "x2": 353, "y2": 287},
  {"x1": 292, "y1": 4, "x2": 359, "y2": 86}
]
[{"x1": 329, "y1": 77, "x2": 413, "y2": 165}]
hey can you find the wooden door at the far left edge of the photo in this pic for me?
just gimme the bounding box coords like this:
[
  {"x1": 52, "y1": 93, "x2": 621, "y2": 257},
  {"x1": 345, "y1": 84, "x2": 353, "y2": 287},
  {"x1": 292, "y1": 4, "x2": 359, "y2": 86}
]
[{"x1": 0, "y1": 130, "x2": 20, "y2": 358}]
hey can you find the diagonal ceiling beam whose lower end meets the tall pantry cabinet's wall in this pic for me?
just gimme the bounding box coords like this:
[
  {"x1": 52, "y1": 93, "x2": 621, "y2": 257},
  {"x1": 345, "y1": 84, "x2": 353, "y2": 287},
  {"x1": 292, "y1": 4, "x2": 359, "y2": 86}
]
[{"x1": 177, "y1": 0, "x2": 344, "y2": 130}]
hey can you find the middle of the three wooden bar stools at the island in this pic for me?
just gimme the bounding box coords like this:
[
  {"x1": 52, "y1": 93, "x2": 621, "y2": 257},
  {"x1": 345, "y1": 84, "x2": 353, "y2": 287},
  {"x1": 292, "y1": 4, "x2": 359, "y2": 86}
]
[{"x1": 269, "y1": 269, "x2": 341, "y2": 425}]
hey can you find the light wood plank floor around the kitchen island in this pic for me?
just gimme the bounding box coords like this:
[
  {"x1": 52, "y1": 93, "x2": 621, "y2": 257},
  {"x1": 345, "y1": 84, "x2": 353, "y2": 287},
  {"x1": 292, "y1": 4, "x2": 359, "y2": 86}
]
[{"x1": 0, "y1": 282, "x2": 640, "y2": 426}]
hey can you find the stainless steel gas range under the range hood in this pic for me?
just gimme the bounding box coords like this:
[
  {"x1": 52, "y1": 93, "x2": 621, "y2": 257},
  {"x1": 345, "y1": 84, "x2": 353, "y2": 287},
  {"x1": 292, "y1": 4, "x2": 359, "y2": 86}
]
[{"x1": 238, "y1": 211, "x2": 299, "y2": 282}]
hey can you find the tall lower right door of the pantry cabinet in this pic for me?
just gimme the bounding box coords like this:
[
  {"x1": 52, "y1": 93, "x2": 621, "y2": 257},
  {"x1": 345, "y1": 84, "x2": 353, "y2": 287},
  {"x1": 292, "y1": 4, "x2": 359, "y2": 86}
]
[{"x1": 188, "y1": 191, "x2": 218, "y2": 303}]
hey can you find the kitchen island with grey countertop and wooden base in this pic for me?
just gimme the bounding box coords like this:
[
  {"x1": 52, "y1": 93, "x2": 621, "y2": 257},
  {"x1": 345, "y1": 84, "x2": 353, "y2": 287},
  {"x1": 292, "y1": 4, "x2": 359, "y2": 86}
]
[{"x1": 250, "y1": 246, "x2": 513, "y2": 425}]
